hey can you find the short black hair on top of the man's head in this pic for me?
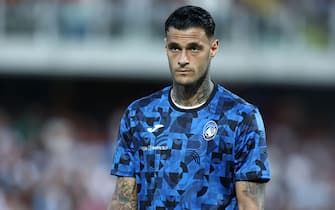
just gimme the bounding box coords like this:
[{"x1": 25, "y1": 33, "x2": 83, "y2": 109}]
[{"x1": 165, "y1": 5, "x2": 215, "y2": 38}]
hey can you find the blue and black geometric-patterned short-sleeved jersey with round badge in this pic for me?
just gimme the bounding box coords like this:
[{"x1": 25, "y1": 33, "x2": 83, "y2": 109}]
[{"x1": 111, "y1": 84, "x2": 270, "y2": 210}]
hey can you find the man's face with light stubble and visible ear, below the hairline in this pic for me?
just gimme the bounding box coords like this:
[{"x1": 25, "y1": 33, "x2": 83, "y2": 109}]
[{"x1": 165, "y1": 27, "x2": 218, "y2": 85}]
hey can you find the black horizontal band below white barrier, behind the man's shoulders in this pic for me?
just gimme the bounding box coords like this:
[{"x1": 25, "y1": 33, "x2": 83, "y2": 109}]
[{"x1": 0, "y1": 76, "x2": 335, "y2": 129}]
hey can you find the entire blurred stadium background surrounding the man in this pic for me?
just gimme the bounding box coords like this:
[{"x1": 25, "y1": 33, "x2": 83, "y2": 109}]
[{"x1": 0, "y1": 0, "x2": 335, "y2": 210}]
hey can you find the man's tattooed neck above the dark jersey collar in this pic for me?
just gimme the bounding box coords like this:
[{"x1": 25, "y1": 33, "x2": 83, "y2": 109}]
[{"x1": 171, "y1": 80, "x2": 214, "y2": 107}]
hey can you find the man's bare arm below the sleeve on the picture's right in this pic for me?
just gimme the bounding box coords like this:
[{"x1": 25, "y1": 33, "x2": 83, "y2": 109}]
[{"x1": 236, "y1": 181, "x2": 265, "y2": 210}]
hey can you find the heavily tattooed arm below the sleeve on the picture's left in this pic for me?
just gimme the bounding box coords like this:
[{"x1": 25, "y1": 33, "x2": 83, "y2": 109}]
[{"x1": 108, "y1": 177, "x2": 137, "y2": 210}]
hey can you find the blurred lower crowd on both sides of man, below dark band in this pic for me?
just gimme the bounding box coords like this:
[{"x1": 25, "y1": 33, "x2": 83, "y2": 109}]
[{"x1": 0, "y1": 89, "x2": 335, "y2": 210}]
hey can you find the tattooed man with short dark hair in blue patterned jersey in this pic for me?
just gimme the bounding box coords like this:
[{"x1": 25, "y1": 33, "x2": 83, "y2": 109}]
[{"x1": 110, "y1": 6, "x2": 270, "y2": 210}]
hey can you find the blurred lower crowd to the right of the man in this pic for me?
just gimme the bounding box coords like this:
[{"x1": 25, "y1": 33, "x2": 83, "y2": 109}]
[{"x1": 266, "y1": 97, "x2": 335, "y2": 210}]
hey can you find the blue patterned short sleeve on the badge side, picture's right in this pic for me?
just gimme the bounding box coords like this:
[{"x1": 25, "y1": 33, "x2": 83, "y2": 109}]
[{"x1": 235, "y1": 108, "x2": 271, "y2": 182}]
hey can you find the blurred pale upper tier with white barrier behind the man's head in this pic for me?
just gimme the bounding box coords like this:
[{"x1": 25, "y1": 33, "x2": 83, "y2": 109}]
[{"x1": 0, "y1": 0, "x2": 335, "y2": 82}]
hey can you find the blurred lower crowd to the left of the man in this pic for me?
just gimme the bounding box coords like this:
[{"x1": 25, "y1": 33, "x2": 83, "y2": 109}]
[{"x1": 0, "y1": 106, "x2": 120, "y2": 210}]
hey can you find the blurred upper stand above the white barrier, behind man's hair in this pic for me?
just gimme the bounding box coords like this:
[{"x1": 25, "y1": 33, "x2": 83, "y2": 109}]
[{"x1": 0, "y1": 0, "x2": 335, "y2": 49}]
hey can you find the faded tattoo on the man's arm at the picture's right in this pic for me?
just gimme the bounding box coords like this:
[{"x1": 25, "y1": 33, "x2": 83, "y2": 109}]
[{"x1": 242, "y1": 182, "x2": 265, "y2": 209}]
